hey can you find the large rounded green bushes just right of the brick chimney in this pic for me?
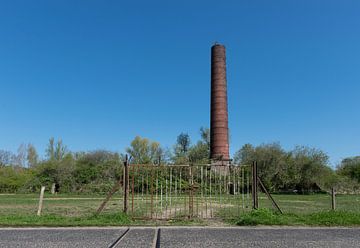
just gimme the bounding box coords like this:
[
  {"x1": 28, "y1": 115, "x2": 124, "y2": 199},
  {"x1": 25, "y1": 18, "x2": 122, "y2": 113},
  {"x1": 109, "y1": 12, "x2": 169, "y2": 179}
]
[{"x1": 234, "y1": 143, "x2": 334, "y2": 192}]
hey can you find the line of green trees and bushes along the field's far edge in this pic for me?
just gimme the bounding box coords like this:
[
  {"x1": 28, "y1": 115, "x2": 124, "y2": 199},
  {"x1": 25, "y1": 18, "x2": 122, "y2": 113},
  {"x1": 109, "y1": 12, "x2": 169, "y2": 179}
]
[{"x1": 0, "y1": 128, "x2": 360, "y2": 193}]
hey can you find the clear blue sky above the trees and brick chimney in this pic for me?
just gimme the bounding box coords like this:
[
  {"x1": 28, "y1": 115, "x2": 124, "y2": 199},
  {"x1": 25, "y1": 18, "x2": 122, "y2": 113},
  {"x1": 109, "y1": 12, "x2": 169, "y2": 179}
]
[{"x1": 0, "y1": 0, "x2": 360, "y2": 165}]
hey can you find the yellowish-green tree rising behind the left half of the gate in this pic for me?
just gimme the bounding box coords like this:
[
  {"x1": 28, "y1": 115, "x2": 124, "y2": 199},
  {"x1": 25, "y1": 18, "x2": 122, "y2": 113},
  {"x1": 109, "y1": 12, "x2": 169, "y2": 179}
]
[{"x1": 126, "y1": 136, "x2": 164, "y2": 164}]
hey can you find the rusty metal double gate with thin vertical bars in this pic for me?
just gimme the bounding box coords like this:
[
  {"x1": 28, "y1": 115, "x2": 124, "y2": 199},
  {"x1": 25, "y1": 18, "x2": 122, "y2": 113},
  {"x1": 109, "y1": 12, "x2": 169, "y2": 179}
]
[{"x1": 125, "y1": 164, "x2": 252, "y2": 220}]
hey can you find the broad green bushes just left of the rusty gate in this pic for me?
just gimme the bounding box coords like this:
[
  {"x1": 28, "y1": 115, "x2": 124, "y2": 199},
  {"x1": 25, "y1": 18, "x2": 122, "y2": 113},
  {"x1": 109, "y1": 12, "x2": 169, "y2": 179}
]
[{"x1": 24, "y1": 150, "x2": 122, "y2": 193}]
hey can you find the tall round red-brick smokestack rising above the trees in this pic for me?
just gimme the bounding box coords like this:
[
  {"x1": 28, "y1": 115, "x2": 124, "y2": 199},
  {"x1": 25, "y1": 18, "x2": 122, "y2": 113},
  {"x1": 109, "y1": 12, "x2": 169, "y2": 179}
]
[{"x1": 210, "y1": 44, "x2": 230, "y2": 160}]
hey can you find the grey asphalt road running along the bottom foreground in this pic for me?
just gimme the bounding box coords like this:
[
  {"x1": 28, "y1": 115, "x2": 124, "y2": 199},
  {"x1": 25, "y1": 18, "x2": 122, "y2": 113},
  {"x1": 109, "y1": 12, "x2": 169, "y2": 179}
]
[{"x1": 0, "y1": 227, "x2": 360, "y2": 248}]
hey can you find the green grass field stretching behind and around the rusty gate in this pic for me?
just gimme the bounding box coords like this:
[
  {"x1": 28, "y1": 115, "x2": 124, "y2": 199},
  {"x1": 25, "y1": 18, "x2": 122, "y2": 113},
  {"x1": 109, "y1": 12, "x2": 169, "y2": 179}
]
[{"x1": 0, "y1": 193, "x2": 360, "y2": 226}]
